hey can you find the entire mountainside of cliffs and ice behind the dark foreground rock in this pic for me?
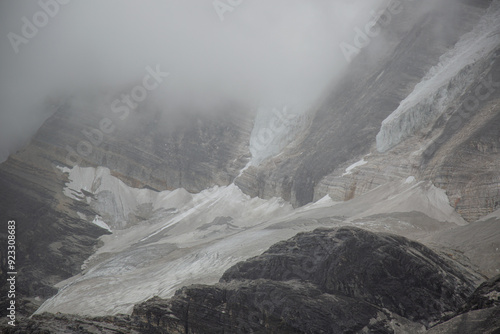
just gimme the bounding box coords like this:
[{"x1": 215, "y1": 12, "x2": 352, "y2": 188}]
[{"x1": 0, "y1": 0, "x2": 500, "y2": 331}]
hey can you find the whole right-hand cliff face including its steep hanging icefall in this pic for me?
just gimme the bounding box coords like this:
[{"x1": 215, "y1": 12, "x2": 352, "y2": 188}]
[{"x1": 236, "y1": 1, "x2": 500, "y2": 221}]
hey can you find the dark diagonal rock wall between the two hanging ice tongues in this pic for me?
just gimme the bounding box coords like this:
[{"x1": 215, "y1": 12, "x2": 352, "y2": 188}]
[{"x1": 236, "y1": 1, "x2": 489, "y2": 211}]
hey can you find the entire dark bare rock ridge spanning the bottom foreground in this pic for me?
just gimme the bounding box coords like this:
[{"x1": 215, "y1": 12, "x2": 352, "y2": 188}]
[{"x1": 10, "y1": 227, "x2": 500, "y2": 334}]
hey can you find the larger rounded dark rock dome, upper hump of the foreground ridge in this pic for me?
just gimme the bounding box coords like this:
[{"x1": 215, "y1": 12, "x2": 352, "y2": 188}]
[{"x1": 221, "y1": 227, "x2": 480, "y2": 323}]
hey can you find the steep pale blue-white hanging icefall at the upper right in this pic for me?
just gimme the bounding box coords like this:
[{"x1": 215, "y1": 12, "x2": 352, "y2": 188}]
[{"x1": 377, "y1": 1, "x2": 500, "y2": 152}]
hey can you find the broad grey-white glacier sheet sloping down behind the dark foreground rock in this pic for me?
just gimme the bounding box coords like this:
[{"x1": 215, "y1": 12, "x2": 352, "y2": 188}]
[{"x1": 37, "y1": 167, "x2": 464, "y2": 316}]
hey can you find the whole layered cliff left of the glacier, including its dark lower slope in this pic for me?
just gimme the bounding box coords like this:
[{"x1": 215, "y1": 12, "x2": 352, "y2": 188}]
[{"x1": 0, "y1": 98, "x2": 252, "y2": 314}]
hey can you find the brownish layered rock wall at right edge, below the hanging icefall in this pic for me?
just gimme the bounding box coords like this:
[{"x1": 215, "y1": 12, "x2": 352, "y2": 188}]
[{"x1": 422, "y1": 46, "x2": 500, "y2": 221}]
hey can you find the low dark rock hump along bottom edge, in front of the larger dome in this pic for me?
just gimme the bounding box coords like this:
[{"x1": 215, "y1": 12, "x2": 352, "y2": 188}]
[{"x1": 134, "y1": 280, "x2": 423, "y2": 333}]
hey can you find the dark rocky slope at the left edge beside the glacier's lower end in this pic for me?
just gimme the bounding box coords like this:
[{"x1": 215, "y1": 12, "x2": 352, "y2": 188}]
[{"x1": 0, "y1": 141, "x2": 106, "y2": 315}]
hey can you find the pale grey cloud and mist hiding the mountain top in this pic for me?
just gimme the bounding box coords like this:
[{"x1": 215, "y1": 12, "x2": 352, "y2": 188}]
[{"x1": 0, "y1": 0, "x2": 387, "y2": 161}]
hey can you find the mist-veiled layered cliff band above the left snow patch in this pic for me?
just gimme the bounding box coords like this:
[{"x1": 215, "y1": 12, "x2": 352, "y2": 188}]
[{"x1": 34, "y1": 95, "x2": 252, "y2": 192}]
